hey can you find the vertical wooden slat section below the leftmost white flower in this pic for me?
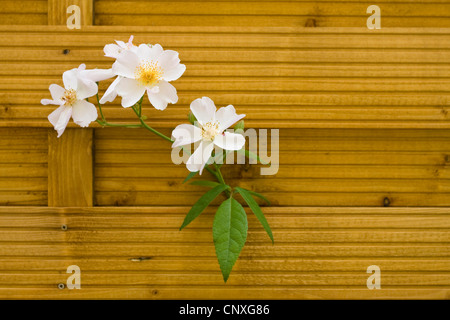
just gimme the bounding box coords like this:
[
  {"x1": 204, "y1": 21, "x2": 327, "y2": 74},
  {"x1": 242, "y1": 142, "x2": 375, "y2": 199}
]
[{"x1": 48, "y1": 129, "x2": 93, "y2": 207}]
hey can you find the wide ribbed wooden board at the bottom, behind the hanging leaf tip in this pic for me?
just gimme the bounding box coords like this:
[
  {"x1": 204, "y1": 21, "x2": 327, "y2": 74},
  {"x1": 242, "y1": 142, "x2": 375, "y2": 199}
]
[{"x1": 0, "y1": 207, "x2": 450, "y2": 299}]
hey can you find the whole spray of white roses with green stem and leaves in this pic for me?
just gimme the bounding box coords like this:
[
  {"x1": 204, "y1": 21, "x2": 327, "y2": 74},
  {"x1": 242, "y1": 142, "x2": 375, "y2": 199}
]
[{"x1": 41, "y1": 36, "x2": 273, "y2": 281}]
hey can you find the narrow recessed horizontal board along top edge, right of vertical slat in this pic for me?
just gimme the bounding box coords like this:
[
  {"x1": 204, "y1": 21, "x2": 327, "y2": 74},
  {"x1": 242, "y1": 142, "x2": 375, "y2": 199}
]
[{"x1": 95, "y1": 0, "x2": 450, "y2": 27}]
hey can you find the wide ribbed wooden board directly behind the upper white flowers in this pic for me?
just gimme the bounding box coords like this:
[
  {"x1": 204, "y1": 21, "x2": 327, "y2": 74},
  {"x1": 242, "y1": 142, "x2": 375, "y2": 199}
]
[{"x1": 0, "y1": 26, "x2": 450, "y2": 128}]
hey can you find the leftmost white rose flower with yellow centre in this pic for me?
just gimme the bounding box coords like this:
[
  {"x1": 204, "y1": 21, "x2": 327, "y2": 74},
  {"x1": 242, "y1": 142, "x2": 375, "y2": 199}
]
[{"x1": 41, "y1": 64, "x2": 114, "y2": 138}]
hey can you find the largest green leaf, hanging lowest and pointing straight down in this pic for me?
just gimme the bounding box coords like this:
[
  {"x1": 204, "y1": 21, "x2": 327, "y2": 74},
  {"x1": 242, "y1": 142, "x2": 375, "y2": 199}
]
[{"x1": 213, "y1": 198, "x2": 248, "y2": 282}]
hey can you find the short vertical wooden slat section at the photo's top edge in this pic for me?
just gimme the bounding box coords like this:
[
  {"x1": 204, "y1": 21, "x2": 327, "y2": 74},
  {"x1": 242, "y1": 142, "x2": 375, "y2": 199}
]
[{"x1": 48, "y1": 0, "x2": 94, "y2": 26}]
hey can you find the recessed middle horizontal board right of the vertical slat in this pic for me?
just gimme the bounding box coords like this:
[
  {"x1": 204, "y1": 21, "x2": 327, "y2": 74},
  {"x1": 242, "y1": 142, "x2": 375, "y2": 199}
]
[{"x1": 95, "y1": 128, "x2": 450, "y2": 206}]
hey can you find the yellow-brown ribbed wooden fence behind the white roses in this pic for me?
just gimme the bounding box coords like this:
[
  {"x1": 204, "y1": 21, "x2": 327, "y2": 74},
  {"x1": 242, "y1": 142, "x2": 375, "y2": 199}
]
[{"x1": 0, "y1": 0, "x2": 450, "y2": 299}]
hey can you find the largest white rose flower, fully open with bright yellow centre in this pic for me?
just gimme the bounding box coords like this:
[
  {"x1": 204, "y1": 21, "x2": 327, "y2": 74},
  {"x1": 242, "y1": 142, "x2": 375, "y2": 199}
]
[{"x1": 100, "y1": 44, "x2": 186, "y2": 110}]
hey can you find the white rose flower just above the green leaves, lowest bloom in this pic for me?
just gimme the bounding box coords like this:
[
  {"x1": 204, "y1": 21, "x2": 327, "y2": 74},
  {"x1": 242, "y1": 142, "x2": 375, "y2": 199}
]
[{"x1": 172, "y1": 97, "x2": 245, "y2": 174}]
